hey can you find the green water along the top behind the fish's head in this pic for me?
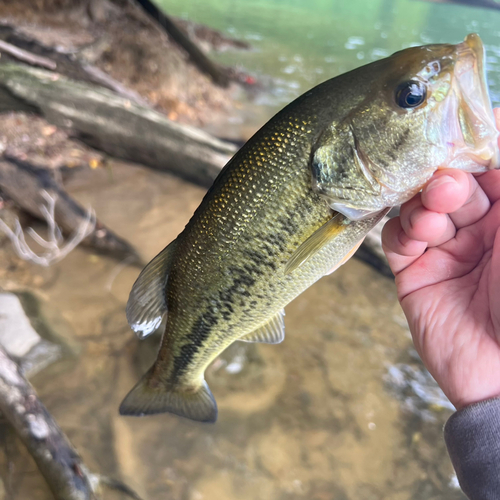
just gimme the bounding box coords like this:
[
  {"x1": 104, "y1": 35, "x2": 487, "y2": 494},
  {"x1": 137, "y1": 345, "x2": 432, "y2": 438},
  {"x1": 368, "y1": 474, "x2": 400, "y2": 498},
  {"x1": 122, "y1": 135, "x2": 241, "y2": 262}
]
[{"x1": 157, "y1": 0, "x2": 500, "y2": 113}]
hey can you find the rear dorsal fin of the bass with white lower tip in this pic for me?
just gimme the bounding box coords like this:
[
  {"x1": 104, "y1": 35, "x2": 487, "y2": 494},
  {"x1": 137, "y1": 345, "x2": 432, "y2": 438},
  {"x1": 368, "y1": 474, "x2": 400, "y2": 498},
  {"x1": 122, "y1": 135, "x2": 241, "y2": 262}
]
[{"x1": 127, "y1": 240, "x2": 177, "y2": 339}]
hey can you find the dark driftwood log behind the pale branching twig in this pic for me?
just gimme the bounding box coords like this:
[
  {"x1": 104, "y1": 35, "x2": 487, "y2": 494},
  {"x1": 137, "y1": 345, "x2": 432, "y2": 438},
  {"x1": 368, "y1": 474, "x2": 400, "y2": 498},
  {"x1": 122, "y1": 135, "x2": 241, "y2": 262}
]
[{"x1": 0, "y1": 155, "x2": 141, "y2": 264}]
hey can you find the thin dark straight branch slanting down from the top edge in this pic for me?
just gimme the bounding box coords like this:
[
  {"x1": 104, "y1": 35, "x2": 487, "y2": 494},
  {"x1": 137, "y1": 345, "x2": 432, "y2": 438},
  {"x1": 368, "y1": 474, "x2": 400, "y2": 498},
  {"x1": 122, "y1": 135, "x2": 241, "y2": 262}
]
[{"x1": 130, "y1": 0, "x2": 230, "y2": 87}]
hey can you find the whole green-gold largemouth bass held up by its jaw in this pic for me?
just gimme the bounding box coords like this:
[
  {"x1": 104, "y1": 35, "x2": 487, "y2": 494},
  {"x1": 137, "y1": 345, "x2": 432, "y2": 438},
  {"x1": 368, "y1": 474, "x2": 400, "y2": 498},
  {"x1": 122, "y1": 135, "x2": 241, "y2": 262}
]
[{"x1": 120, "y1": 35, "x2": 500, "y2": 421}]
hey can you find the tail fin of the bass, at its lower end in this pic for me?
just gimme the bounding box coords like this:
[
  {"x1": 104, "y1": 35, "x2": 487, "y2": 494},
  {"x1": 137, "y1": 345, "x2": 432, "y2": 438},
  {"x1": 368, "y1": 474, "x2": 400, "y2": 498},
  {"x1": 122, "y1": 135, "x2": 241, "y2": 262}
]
[{"x1": 120, "y1": 369, "x2": 217, "y2": 422}]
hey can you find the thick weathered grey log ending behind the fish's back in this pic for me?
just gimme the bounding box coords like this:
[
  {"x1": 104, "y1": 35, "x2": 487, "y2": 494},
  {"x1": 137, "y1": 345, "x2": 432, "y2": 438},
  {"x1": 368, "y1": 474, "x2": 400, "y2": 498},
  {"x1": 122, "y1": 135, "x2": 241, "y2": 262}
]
[{"x1": 0, "y1": 63, "x2": 236, "y2": 187}]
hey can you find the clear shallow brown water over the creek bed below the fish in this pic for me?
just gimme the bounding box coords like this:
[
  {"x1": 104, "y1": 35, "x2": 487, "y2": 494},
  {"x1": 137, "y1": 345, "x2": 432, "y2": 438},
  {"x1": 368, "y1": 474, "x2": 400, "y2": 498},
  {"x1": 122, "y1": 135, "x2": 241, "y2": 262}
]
[{"x1": 0, "y1": 163, "x2": 465, "y2": 500}]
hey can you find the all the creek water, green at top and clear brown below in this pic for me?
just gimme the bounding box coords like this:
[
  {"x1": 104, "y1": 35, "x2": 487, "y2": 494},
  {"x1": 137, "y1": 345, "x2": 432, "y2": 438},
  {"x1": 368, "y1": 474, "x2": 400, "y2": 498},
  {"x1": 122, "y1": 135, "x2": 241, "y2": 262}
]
[{"x1": 0, "y1": 0, "x2": 492, "y2": 500}]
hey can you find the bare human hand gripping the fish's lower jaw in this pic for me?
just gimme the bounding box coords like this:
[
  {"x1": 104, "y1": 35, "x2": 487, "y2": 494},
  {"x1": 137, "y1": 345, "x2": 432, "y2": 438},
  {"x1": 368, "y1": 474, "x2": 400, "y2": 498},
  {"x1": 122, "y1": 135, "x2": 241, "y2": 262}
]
[{"x1": 382, "y1": 109, "x2": 500, "y2": 409}]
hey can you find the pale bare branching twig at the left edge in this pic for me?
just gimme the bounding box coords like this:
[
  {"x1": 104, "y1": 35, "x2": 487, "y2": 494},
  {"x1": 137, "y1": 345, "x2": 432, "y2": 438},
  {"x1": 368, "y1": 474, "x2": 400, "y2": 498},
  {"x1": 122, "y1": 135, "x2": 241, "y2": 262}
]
[{"x1": 0, "y1": 190, "x2": 96, "y2": 267}]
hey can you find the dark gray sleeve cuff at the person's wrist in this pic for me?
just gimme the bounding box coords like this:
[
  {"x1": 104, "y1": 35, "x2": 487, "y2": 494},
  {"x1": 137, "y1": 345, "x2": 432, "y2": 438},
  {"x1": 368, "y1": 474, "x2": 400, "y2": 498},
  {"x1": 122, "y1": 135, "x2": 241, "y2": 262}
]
[{"x1": 444, "y1": 398, "x2": 500, "y2": 500}]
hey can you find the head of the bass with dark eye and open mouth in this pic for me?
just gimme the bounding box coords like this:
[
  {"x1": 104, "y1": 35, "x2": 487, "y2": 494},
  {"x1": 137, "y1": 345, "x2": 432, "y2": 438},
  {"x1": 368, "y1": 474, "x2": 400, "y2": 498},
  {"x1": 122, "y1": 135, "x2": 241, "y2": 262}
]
[{"x1": 311, "y1": 34, "x2": 500, "y2": 220}]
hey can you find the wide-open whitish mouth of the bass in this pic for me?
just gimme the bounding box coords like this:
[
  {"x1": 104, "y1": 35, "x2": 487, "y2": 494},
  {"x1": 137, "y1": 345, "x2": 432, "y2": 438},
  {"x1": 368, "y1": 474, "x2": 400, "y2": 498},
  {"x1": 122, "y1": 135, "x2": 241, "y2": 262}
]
[{"x1": 445, "y1": 34, "x2": 500, "y2": 172}]
